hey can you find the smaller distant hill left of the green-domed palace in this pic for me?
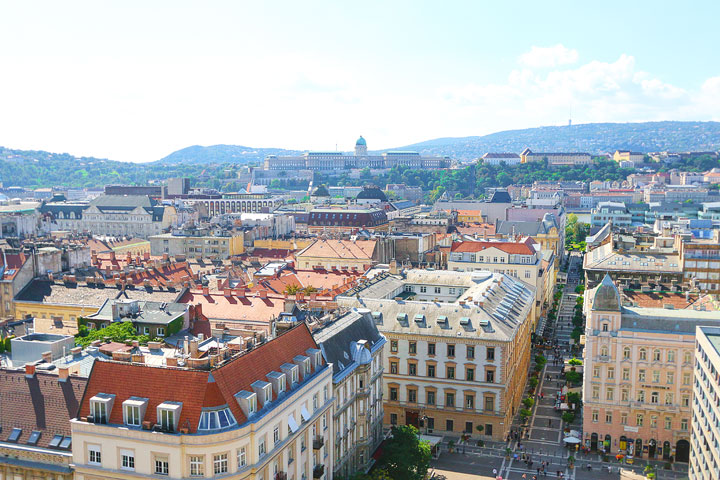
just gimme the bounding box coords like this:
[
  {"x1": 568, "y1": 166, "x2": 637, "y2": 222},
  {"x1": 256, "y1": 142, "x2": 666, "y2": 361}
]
[{"x1": 158, "y1": 145, "x2": 300, "y2": 164}]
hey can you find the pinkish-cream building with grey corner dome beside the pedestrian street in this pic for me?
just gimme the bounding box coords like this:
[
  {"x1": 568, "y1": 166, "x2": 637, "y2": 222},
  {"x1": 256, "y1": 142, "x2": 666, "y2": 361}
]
[{"x1": 583, "y1": 275, "x2": 720, "y2": 462}]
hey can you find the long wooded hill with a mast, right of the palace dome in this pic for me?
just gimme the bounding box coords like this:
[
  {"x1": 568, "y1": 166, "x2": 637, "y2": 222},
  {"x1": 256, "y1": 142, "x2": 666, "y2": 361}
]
[{"x1": 394, "y1": 122, "x2": 720, "y2": 160}]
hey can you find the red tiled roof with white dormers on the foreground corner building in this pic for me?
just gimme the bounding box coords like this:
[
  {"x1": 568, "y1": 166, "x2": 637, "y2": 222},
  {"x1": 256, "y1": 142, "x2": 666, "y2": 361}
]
[{"x1": 78, "y1": 323, "x2": 317, "y2": 433}]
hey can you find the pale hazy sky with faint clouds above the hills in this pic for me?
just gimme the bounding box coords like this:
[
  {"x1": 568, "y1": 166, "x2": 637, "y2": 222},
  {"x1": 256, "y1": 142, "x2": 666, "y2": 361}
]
[{"x1": 0, "y1": 0, "x2": 720, "y2": 161}]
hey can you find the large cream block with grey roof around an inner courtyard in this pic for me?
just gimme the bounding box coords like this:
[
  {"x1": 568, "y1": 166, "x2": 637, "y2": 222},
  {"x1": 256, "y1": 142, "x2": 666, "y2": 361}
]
[{"x1": 338, "y1": 270, "x2": 535, "y2": 440}]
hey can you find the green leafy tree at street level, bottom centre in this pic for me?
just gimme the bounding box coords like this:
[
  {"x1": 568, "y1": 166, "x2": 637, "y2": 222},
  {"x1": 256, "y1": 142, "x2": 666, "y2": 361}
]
[{"x1": 377, "y1": 425, "x2": 431, "y2": 480}]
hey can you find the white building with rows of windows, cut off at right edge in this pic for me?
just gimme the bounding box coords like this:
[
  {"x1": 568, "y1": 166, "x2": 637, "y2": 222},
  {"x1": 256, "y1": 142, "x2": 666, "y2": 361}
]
[{"x1": 689, "y1": 326, "x2": 720, "y2": 480}]
